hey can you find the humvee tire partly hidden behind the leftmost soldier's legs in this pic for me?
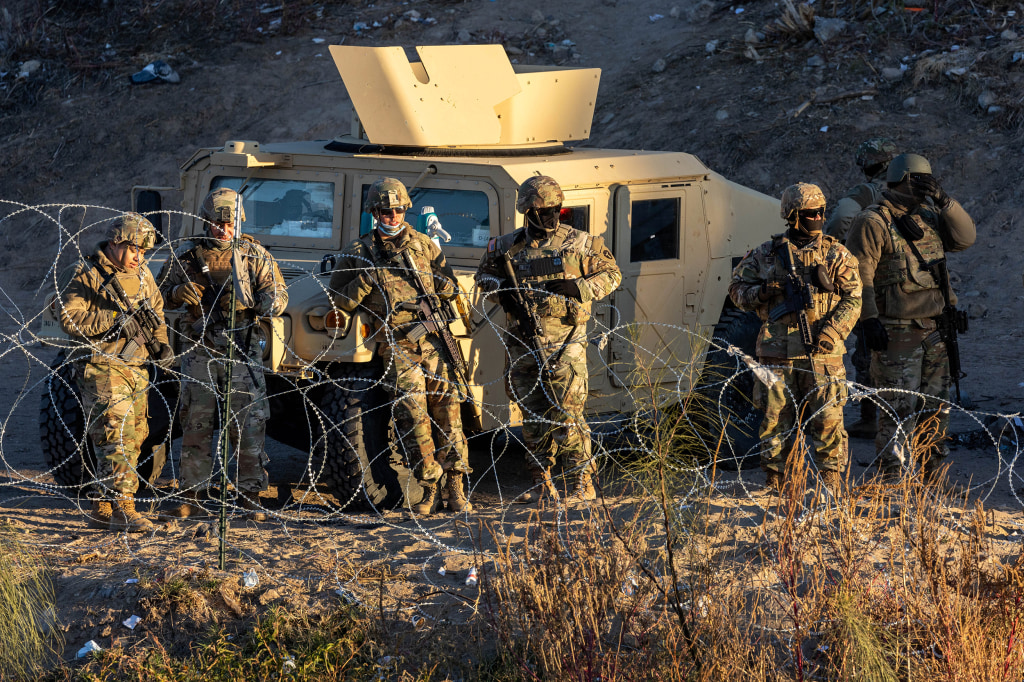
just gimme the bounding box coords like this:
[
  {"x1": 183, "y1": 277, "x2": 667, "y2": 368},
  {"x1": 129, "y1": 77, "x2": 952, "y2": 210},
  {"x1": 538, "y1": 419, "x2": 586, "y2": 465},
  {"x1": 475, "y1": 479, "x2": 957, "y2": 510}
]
[{"x1": 39, "y1": 351, "x2": 168, "y2": 488}]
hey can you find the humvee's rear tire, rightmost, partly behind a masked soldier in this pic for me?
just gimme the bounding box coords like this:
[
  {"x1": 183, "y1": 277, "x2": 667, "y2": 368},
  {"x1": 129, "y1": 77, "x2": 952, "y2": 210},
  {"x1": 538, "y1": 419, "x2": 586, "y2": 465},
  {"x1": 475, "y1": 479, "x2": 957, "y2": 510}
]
[{"x1": 697, "y1": 307, "x2": 764, "y2": 471}]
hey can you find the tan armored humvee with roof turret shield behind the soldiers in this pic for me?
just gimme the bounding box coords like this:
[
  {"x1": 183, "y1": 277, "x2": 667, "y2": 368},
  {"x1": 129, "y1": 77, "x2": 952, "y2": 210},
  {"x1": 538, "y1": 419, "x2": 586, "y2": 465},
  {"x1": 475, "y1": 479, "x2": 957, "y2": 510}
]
[{"x1": 41, "y1": 45, "x2": 781, "y2": 505}]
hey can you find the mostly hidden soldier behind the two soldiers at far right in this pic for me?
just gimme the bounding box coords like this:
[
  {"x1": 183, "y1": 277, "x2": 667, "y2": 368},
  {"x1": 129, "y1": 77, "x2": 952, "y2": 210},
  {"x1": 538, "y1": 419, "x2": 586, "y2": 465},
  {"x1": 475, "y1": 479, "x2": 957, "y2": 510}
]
[{"x1": 824, "y1": 137, "x2": 897, "y2": 438}]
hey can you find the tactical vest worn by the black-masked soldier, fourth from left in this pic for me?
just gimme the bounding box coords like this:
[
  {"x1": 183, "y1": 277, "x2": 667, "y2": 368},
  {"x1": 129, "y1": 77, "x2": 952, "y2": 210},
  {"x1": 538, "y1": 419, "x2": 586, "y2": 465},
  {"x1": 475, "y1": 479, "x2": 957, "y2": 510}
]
[{"x1": 496, "y1": 224, "x2": 594, "y2": 326}]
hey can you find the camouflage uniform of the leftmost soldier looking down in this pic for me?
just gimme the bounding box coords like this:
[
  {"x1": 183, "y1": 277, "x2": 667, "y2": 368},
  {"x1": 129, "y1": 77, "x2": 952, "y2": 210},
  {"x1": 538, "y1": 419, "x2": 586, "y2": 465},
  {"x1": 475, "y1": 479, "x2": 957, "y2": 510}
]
[{"x1": 58, "y1": 236, "x2": 167, "y2": 499}]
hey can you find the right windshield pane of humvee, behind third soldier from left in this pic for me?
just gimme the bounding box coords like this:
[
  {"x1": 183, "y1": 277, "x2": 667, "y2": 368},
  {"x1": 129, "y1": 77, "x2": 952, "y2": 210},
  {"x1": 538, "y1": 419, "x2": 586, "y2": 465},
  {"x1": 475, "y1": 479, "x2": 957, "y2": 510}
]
[{"x1": 359, "y1": 184, "x2": 490, "y2": 248}]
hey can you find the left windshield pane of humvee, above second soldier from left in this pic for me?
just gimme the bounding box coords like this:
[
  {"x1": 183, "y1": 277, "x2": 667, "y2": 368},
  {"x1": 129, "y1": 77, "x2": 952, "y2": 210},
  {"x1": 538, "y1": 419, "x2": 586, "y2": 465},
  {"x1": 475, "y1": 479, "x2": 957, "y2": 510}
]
[{"x1": 210, "y1": 177, "x2": 334, "y2": 239}]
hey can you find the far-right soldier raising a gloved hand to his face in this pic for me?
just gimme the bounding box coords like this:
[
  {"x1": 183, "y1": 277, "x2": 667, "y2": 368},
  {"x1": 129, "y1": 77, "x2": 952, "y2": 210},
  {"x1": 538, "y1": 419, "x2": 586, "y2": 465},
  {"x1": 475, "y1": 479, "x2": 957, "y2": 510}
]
[{"x1": 848, "y1": 154, "x2": 977, "y2": 475}]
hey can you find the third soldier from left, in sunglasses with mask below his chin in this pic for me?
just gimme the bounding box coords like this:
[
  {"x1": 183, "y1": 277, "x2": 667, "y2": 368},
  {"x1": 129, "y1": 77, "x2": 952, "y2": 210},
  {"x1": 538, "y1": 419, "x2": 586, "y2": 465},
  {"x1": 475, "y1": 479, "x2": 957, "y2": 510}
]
[{"x1": 331, "y1": 178, "x2": 473, "y2": 515}]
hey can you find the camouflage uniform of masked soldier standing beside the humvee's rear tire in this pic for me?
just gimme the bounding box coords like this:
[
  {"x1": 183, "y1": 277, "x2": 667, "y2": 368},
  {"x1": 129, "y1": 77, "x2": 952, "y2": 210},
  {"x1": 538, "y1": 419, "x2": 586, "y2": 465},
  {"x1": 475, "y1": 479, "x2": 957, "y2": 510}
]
[{"x1": 729, "y1": 229, "x2": 861, "y2": 474}]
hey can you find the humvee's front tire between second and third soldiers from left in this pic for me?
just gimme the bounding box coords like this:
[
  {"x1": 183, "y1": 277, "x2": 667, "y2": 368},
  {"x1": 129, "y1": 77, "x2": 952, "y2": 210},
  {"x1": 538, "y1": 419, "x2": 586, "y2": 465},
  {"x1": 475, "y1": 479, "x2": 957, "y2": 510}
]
[{"x1": 313, "y1": 363, "x2": 423, "y2": 509}]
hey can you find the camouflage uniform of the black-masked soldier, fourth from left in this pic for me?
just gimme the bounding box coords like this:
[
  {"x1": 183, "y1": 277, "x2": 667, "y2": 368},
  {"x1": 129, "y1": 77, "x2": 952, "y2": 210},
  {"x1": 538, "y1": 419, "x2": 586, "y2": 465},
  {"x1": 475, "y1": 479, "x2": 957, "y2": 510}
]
[{"x1": 476, "y1": 224, "x2": 623, "y2": 481}]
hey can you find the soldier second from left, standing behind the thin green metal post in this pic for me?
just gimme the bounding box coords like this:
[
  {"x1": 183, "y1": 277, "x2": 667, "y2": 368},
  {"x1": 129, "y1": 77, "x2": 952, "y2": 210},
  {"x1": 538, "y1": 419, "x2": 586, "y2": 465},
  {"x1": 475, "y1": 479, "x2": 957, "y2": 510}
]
[{"x1": 159, "y1": 187, "x2": 288, "y2": 520}]
